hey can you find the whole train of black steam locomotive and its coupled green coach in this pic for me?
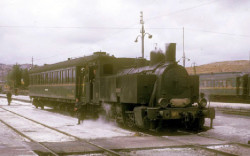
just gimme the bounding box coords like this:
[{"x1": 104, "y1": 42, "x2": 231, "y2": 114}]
[{"x1": 29, "y1": 43, "x2": 215, "y2": 130}]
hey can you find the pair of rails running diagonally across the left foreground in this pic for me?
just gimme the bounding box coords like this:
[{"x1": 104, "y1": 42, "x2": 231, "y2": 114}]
[{"x1": 0, "y1": 107, "x2": 120, "y2": 156}]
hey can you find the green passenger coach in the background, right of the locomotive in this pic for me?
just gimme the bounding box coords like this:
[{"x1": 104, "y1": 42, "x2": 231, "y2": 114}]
[{"x1": 200, "y1": 72, "x2": 250, "y2": 102}]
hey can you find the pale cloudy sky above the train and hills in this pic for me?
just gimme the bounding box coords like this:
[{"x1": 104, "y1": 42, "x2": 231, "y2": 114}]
[{"x1": 0, "y1": 0, "x2": 250, "y2": 66}]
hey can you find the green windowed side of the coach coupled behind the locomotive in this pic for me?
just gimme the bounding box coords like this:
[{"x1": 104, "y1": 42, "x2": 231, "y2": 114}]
[{"x1": 29, "y1": 68, "x2": 76, "y2": 100}]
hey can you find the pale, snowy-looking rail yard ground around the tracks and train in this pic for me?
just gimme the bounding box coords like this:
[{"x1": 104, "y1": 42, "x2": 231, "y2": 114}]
[{"x1": 0, "y1": 97, "x2": 250, "y2": 155}]
